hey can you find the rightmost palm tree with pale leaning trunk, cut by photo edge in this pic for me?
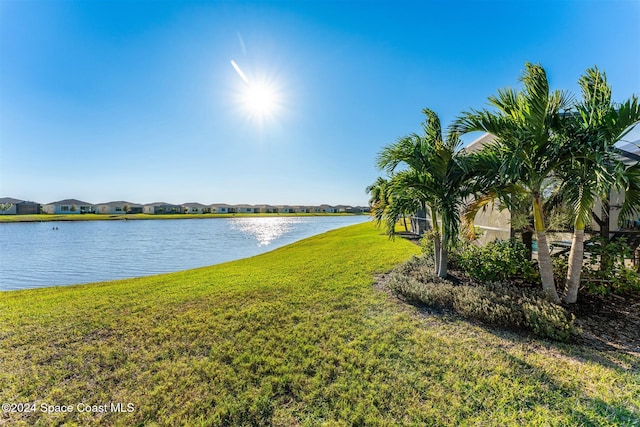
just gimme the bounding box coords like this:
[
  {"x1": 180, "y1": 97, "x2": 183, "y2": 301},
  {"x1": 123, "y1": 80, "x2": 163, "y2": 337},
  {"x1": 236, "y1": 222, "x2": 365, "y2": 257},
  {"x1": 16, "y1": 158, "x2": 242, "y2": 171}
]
[{"x1": 558, "y1": 67, "x2": 640, "y2": 303}]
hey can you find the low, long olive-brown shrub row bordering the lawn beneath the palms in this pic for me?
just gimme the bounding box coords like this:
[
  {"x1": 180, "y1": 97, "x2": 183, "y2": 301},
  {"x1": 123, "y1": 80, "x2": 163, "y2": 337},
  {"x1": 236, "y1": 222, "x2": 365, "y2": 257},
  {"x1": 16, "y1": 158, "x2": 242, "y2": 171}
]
[{"x1": 387, "y1": 257, "x2": 575, "y2": 341}]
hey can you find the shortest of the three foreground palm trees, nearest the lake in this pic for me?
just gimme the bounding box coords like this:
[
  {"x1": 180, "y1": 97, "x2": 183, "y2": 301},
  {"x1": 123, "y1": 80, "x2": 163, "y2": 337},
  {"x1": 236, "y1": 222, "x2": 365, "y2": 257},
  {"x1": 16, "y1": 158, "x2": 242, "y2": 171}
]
[{"x1": 377, "y1": 109, "x2": 466, "y2": 277}]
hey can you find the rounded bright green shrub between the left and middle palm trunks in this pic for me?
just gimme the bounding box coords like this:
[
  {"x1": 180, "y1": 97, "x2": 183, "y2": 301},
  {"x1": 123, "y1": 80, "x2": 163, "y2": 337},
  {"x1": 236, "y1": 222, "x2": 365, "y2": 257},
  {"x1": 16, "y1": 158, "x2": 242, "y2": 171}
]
[{"x1": 453, "y1": 239, "x2": 539, "y2": 283}]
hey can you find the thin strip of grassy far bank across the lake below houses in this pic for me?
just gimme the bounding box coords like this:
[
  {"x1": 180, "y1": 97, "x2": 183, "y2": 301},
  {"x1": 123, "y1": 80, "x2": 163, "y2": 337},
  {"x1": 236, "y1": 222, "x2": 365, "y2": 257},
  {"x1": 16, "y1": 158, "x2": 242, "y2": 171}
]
[{"x1": 0, "y1": 212, "x2": 362, "y2": 224}]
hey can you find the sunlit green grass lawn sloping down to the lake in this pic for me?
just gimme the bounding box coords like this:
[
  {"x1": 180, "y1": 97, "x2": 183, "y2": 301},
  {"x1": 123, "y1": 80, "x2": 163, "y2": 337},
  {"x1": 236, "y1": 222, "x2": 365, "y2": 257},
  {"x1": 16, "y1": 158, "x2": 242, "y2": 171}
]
[{"x1": 0, "y1": 223, "x2": 640, "y2": 426}]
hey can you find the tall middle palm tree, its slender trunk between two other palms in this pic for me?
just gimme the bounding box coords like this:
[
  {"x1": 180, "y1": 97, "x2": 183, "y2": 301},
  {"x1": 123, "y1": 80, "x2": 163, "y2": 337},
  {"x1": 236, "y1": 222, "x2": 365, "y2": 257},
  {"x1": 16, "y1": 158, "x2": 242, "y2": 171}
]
[{"x1": 453, "y1": 63, "x2": 570, "y2": 303}]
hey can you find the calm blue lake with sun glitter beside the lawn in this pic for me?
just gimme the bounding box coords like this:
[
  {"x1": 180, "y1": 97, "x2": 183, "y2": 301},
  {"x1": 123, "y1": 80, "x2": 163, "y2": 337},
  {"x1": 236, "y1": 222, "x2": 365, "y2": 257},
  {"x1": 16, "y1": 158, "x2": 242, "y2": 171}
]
[{"x1": 0, "y1": 215, "x2": 369, "y2": 291}]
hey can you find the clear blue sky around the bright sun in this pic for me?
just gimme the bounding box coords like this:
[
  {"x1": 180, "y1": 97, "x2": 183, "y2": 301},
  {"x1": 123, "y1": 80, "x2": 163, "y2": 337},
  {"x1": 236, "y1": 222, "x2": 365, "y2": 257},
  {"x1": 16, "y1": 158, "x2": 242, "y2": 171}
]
[{"x1": 0, "y1": 0, "x2": 640, "y2": 205}]
